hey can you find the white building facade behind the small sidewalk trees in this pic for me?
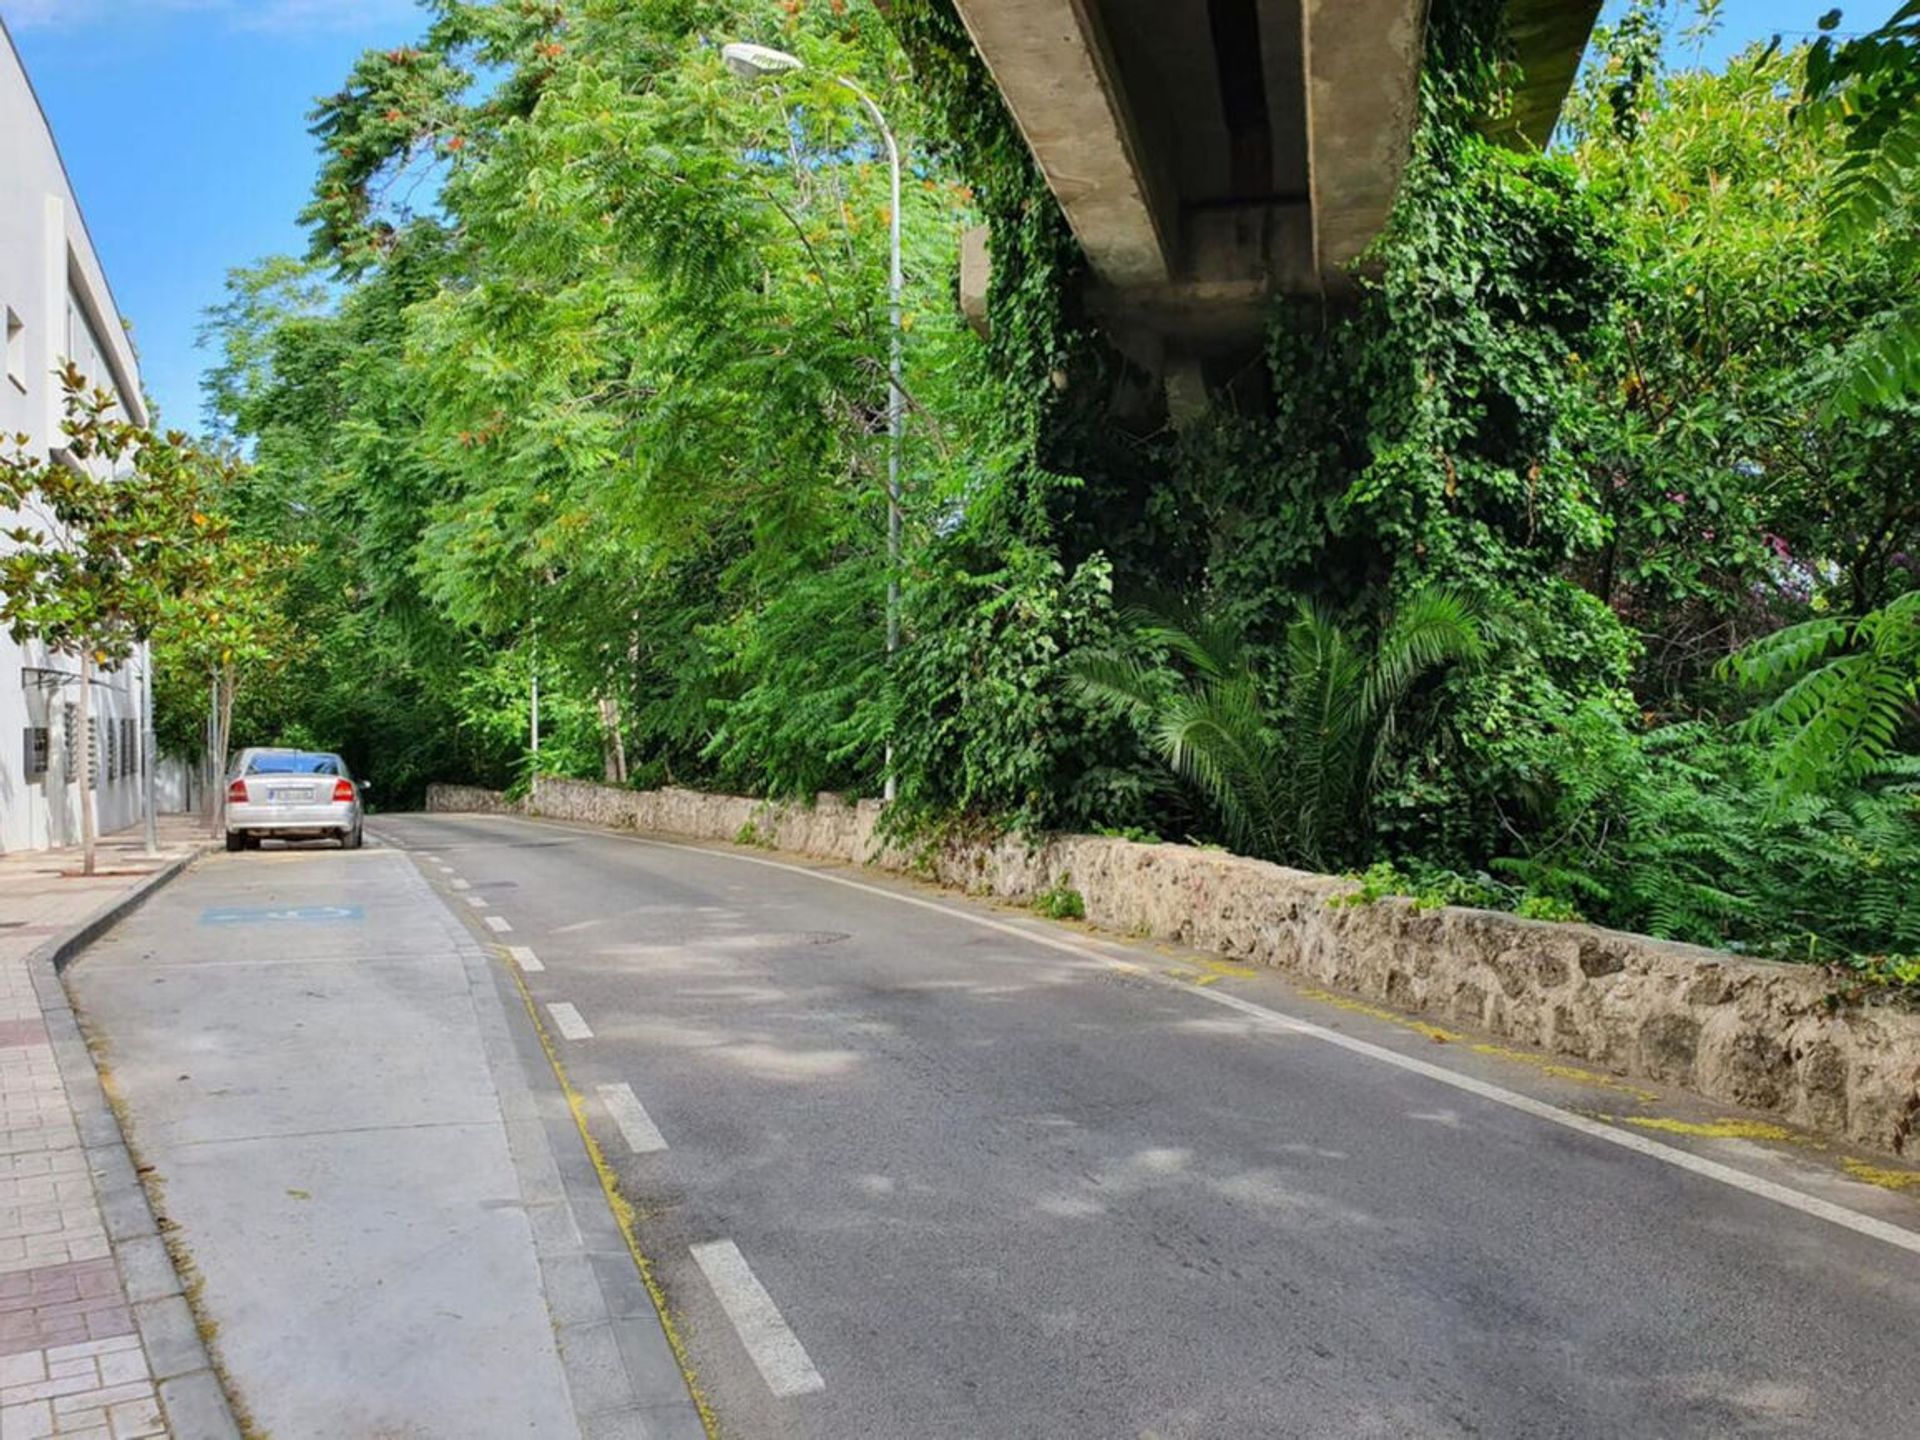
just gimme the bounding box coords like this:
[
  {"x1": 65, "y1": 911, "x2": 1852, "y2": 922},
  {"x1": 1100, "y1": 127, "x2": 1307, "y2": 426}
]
[{"x1": 0, "y1": 21, "x2": 146, "y2": 851}]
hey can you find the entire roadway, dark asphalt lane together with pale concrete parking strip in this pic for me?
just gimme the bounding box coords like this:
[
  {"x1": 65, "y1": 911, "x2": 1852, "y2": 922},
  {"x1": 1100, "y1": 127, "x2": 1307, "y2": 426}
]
[{"x1": 69, "y1": 816, "x2": 1920, "y2": 1440}]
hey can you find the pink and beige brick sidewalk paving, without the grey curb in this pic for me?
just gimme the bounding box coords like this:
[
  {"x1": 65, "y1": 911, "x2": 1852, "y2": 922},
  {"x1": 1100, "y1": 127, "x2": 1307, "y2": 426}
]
[{"x1": 0, "y1": 816, "x2": 211, "y2": 1440}]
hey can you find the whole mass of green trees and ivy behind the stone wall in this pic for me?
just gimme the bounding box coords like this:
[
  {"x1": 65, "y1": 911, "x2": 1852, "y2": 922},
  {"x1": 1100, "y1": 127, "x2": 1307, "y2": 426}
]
[{"x1": 180, "y1": 0, "x2": 1920, "y2": 975}]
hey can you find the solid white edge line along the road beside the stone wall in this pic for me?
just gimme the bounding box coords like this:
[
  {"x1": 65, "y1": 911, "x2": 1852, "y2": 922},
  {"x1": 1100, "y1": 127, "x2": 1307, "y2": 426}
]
[{"x1": 487, "y1": 816, "x2": 1920, "y2": 1254}]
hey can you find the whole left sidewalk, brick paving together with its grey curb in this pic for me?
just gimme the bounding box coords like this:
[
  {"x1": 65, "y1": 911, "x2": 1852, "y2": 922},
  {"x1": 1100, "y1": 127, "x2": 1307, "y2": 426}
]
[{"x1": 0, "y1": 816, "x2": 236, "y2": 1440}]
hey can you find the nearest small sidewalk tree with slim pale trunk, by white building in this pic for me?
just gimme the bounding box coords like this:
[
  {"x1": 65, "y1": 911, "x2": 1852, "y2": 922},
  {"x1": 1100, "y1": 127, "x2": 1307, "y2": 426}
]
[{"x1": 0, "y1": 365, "x2": 217, "y2": 876}]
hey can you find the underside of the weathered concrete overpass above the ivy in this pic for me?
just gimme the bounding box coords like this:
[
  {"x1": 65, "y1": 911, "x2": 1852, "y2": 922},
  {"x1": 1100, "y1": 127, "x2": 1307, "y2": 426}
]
[{"x1": 954, "y1": 0, "x2": 1599, "y2": 395}]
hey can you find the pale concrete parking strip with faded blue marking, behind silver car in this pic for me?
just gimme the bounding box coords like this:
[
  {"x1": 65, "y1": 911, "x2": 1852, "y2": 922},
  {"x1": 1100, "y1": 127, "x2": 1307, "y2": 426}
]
[{"x1": 69, "y1": 849, "x2": 701, "y2": 1440}]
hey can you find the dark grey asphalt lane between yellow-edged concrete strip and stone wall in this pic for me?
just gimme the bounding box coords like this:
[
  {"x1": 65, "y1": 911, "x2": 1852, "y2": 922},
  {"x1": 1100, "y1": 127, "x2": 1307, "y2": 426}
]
[{"x1": 378, "y1": 816, "x2": 1920, "y2": 1440}]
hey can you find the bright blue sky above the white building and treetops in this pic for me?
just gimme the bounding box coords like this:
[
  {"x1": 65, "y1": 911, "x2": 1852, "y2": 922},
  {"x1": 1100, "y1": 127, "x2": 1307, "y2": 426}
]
[{"x1": 0, "y1": 0, "x2": 1897, "y2": 439}]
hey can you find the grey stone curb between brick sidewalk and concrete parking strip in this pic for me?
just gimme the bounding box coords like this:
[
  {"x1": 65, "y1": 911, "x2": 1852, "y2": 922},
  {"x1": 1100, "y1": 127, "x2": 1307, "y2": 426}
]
[{"x1": 27, "y1": 845, "x2": 244, "y2": 1440}]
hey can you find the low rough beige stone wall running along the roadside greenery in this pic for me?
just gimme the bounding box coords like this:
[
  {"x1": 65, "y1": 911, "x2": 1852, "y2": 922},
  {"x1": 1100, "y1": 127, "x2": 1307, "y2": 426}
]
[{"x1": 428, "y1": 780, "x2": 1920, "y2": 1154}]
